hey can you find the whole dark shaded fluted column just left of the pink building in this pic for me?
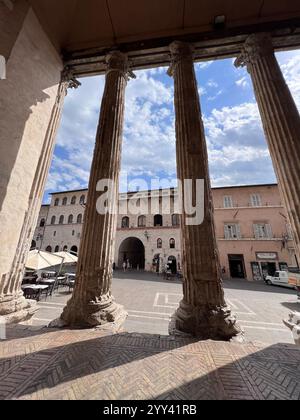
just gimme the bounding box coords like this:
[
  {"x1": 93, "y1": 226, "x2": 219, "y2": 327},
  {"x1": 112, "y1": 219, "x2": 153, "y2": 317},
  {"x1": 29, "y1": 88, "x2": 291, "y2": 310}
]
[{"x1": 169, "y1": 42, "x2": 240, "y2": 340}]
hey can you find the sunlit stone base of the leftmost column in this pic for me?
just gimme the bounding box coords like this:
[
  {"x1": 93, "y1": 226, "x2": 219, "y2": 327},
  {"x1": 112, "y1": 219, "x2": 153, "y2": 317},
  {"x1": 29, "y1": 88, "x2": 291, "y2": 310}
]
[{"x1": 0, "y1": 292, "x2": 38, "y2": 325}]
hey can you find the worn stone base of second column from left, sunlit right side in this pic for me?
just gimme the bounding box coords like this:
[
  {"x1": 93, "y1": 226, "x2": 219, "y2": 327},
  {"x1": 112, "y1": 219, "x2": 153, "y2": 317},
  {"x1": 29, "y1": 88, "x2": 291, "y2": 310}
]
[{"x1": 48, "y1": 300, "x2": 128, "y2": 332}]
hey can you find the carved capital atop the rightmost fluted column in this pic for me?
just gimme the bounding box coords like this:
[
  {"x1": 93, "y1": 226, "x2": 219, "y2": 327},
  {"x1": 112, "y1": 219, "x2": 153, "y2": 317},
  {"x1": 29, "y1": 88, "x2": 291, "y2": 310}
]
[{"x1": 234, "y1": 32, "x2": 274, "y2": 67}]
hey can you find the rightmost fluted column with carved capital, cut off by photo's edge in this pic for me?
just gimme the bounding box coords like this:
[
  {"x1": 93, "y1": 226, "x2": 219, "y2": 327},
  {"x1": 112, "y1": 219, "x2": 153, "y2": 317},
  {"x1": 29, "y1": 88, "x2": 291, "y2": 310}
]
[{"x1": 235, "y1": 33, "x2": 300, "y2": 261}]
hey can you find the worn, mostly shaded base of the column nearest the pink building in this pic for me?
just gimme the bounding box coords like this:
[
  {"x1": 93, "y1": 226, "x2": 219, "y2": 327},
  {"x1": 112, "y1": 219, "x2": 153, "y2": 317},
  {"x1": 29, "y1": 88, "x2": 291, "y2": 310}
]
[{"x1": 169, "y1": 301, "x2": 243, "y2": 341}]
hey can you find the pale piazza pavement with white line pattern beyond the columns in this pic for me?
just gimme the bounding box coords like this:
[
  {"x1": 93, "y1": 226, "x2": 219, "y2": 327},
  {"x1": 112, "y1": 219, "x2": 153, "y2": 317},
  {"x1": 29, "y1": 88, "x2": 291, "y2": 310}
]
[{"x1": 29, "y1": 272, "x2": 300, "y2": 345}]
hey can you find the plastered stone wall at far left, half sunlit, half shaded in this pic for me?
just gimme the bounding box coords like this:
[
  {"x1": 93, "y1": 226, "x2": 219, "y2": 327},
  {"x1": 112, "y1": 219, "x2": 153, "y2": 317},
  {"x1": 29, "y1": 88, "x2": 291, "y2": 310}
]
[{"x1": 0, "y1": 10, "x2": 62, "y2": 278}]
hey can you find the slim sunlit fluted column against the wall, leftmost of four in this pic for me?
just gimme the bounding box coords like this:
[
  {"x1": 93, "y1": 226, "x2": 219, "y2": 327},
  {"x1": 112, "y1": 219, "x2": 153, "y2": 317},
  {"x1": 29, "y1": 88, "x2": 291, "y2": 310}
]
[{"x1": 0, "y1": 71, "x2": 80, "y2": 323}]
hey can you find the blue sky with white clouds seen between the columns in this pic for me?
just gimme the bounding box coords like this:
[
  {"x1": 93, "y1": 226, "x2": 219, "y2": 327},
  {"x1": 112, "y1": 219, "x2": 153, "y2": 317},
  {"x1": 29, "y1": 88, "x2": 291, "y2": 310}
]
[{"x1": 44, "y1": 50, "x2": 300, "y2": 202}]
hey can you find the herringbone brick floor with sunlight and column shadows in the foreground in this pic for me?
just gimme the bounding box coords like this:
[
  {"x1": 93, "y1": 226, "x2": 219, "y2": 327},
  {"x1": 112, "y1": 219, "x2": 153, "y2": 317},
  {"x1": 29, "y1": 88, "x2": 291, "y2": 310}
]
[{"x1": 0, "y1": 326, "x2": 300, "y2": 400}]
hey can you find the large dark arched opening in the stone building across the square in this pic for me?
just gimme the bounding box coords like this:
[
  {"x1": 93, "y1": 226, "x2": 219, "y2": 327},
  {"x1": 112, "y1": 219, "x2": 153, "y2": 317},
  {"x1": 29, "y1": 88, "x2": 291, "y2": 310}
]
[{"x1": 118, "y1": 237, "x2": 145, "y2": 270}]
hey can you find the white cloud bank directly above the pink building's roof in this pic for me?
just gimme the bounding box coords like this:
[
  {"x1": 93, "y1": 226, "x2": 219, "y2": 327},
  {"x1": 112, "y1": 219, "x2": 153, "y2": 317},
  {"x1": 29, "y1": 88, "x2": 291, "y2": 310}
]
[{"x1": 204, "y1": 102, "x2": 275, "y2": 186}]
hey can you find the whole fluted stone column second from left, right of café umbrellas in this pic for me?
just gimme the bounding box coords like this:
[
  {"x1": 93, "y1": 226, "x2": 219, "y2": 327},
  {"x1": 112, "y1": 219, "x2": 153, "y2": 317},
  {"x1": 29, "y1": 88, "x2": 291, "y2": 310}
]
[{"x1": 58, "y1": 52, "x2": 130, "y2": 329}]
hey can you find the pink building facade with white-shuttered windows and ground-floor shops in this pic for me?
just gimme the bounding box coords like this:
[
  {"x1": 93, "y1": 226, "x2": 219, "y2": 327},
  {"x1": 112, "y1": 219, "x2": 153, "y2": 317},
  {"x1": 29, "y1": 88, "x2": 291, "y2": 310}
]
[{"x1": 213, "y1": 184, "x2": 299, "y2": 280}]
